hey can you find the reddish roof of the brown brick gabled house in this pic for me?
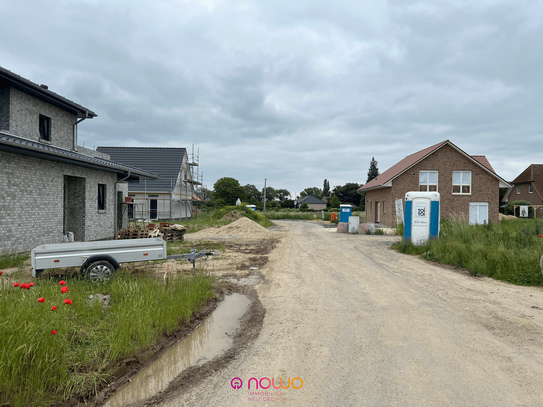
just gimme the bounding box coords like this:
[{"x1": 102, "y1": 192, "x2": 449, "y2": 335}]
[{"x1": 358, "y1": 140, "x2": 509, "y2": 191}]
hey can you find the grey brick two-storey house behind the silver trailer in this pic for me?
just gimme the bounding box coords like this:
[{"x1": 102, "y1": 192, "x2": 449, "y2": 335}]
[{"x1": 0, "y1": 67, "x2": 158, "y2": 253}]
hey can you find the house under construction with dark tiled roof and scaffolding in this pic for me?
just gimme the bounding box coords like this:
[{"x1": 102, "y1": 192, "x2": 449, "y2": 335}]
[{"x1": 97, "y1": 147, "x2": 201, "y2": 220}]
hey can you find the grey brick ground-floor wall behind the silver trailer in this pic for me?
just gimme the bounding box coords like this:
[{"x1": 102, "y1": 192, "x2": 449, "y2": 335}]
[{"x1": 0, "y1": 151, "x2": 117, "y2": 253}]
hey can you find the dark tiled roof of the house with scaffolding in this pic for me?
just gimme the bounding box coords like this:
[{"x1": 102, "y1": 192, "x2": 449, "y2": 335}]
[{"x1": 96, "y1": 147, "x2": 187, "y2": 192}]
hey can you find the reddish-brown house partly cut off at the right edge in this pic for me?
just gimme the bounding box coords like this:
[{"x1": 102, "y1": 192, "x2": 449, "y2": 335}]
[{"x1": 502, "y1": 164, "x2": 543, "y2": 216}]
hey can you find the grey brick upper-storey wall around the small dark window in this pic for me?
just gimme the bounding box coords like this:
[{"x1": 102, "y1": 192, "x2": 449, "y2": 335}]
[{"x1": 10, "y1": 88, "x2": 77, "y2": 150}]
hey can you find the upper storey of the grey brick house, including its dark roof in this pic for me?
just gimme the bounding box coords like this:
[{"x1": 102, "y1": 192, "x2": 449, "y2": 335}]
[{"x1": 0, "y1": 67, "x2": 97, "y2": 151}]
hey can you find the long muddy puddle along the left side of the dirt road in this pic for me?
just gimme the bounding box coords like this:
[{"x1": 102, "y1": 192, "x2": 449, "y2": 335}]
[{"x1": 104, "y1": 294, "x2": 250, "y2": 407}]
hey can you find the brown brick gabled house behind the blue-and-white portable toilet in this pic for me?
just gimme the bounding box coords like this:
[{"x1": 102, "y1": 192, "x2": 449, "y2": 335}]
[{"x1": 358, "y1": 140, "x2": 510, "y2": 226}]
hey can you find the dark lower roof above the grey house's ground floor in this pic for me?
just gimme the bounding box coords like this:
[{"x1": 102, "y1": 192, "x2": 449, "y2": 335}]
[{"x1": 0, "y1": 132, "x2": 158, "y2": 180}]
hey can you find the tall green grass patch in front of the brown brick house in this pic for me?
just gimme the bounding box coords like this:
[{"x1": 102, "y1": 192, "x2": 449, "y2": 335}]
[{"x1": 393, "y1": 219, "x2": 543, "y2": 285}]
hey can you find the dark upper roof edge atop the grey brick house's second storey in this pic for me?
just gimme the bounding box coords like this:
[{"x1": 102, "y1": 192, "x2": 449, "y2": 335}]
[{"x1": 0, "y1": 66, "x2": 97, "y2": 119}]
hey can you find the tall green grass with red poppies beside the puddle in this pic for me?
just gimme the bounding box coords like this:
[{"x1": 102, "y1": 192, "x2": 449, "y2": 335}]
[{"x1": 0, "y1": 274, "x2": 213, "y2": 406}]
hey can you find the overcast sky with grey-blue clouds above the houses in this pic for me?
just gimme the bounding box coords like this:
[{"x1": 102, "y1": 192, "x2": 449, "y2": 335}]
[{"x1": 0, "y1": 0, "x2": 543, "y2": 196}]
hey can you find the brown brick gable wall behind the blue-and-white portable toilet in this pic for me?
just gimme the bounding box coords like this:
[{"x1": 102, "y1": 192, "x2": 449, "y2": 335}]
[{"x1": 366, "y1": 145, "x2": 499, "y2": 226}]
